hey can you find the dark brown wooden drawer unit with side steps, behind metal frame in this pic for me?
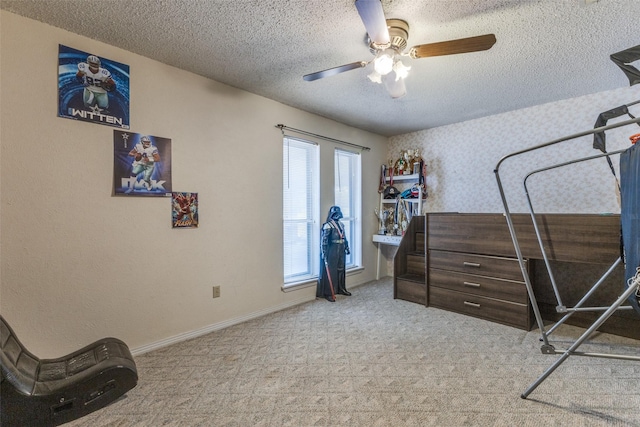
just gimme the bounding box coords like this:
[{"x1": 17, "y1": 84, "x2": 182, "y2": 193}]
[{"x1": 394, "y1": 213, "x2": 640, "y2": 339}]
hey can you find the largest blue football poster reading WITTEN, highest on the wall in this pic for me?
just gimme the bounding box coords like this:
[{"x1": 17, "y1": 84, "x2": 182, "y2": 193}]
[{"x1": 58, "y1": 45, "x2": 129, "y2": 129}]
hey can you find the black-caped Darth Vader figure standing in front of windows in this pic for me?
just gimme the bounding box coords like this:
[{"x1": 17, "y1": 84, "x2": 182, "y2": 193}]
[{"x1": 316, "y1": 206, "x2": 351, "y2": 302}]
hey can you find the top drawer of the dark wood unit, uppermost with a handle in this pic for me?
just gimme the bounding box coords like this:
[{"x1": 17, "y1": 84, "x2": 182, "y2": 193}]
[{"x1": 429, "y1": 250, "x2": 526, "y2": 281}]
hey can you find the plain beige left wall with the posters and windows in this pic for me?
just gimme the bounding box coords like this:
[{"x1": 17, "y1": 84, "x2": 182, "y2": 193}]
[{"x1": 0, "y1": 11, "x2": 387, "y2": 357}]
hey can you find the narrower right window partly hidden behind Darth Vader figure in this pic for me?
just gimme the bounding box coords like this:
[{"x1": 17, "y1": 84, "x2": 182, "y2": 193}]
[{"x1": 334, "y1": 149, "x2": 362, "y2": 268}]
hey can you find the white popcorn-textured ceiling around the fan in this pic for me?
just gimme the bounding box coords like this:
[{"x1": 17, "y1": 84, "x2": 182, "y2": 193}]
[{"x1": 0, "y1": 0, "x2": 640, "y2": 136}]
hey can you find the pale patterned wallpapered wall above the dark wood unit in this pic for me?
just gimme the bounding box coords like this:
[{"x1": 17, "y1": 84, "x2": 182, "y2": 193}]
[{"x1": 388, "y1": 85, "x2": 640, "y2": 213}]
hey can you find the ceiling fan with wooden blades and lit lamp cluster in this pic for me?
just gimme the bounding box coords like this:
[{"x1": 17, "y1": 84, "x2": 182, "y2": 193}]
[{"x1": 302, "y1": 0, "x2": 496, "y2": 98}]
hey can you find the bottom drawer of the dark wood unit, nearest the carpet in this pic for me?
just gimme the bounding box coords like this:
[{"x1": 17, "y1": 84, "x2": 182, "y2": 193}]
[{"x1": 429, "y1": 287, "x2": 531, "y2": 330}]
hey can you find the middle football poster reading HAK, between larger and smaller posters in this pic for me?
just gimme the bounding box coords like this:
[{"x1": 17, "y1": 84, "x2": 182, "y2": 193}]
[{"x1": 113, "y1": 130, "x2": 171, "y2": 197}]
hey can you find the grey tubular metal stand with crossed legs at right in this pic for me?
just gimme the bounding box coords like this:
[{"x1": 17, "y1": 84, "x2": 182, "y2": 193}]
[{"x1": 494, "y1": 114, "x2": 640, "y2": 399}]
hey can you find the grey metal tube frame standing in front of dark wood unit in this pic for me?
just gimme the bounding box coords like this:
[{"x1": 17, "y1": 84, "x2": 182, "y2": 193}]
[{"x1": 494, "y1": 114, "x2": 640, "y2": 399}]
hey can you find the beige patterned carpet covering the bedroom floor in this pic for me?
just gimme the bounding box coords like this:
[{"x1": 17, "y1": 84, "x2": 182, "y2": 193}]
[{"x1": 67, "y1": 278, "x2": 640, "y2": 427}]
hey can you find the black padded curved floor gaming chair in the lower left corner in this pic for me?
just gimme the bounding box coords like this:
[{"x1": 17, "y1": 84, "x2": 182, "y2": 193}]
[{"x1": 0, "y1": 316, "x2": 138, "y2": 427}]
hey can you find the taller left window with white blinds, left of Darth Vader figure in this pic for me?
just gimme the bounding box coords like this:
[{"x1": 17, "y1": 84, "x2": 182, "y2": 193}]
[{"x1": 282, "y1": 137, "x2": 320, "y2": 284}]
